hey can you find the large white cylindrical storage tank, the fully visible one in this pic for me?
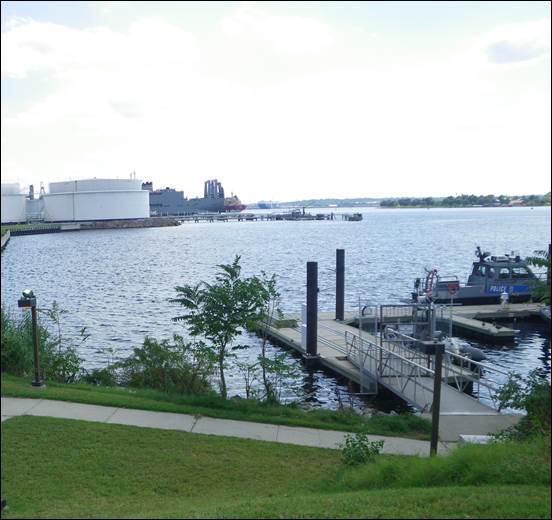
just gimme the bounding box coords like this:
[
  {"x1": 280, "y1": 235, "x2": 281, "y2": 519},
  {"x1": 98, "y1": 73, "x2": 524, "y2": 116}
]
[{"x1": 44, "y1": 179, "x2": 150, "y2": 222}]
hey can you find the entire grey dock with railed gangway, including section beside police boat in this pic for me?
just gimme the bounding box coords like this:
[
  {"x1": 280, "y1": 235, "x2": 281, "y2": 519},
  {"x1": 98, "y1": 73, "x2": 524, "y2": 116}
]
[{"x1": 266, "y1": 304, "x2": 541, "y2": 441}]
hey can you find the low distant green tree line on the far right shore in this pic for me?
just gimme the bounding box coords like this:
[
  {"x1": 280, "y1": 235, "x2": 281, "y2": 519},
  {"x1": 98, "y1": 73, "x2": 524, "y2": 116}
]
[{"x1": 380, "y1": 192, "x2": 550, "y2": 208}]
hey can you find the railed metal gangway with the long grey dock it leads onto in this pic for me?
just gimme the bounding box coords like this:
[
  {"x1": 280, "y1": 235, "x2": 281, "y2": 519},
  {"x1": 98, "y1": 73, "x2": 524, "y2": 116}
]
[{"x1": 267, "y1": 314, "x2": 519, "y2": 441}]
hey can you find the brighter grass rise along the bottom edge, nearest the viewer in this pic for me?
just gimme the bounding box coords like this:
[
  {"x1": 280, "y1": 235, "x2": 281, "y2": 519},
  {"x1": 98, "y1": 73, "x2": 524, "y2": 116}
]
[{"x1": 170, "y1": 486, "x2": 550, "y2": 518}]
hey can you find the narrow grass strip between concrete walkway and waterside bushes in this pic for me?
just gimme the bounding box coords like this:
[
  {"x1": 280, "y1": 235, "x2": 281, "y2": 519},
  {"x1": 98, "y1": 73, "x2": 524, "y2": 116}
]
[{"x1": 2, "y1": 374, "x2": 431, "y2": 440}]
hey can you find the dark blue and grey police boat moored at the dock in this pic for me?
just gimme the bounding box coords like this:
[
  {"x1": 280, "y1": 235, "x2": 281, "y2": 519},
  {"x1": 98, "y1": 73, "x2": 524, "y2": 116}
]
[{"x1": 412, "y1": 246, "x2": 538, "y2": 305}]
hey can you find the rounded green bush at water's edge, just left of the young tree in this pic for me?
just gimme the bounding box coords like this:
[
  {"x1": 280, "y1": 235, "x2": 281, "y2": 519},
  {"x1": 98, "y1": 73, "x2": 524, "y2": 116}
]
[{"x1": 113, "y1": 335, "x2": 215, "y2": 394}]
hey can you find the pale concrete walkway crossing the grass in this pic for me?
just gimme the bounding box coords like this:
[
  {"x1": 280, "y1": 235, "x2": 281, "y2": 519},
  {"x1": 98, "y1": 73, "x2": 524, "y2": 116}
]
[{"x1": 2, "y1": 397, "x2": 451, "y2": 456}]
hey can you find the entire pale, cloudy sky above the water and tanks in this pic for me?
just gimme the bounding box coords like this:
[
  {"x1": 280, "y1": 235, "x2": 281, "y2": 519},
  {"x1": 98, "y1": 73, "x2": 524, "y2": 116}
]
[{"x1": 1, "y1": 1, "x2": 551, "y2": 203}]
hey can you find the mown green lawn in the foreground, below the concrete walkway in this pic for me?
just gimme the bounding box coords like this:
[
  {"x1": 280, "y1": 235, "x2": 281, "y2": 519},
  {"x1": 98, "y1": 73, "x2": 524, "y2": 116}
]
[{"x1": 2, "y1": 416, "x2": 551, "y2": 518}]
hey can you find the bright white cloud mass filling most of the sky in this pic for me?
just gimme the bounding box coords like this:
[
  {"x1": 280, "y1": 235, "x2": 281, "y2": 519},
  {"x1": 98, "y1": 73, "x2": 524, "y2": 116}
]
[{"x1": 2, "y1": 5, "x2": 550, "y2": 201}]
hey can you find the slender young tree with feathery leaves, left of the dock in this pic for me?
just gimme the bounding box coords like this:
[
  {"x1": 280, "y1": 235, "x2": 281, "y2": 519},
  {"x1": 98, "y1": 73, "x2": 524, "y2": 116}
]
[{"x1": 171, "y1": 256, "x2": 268, "y2": 398}]
